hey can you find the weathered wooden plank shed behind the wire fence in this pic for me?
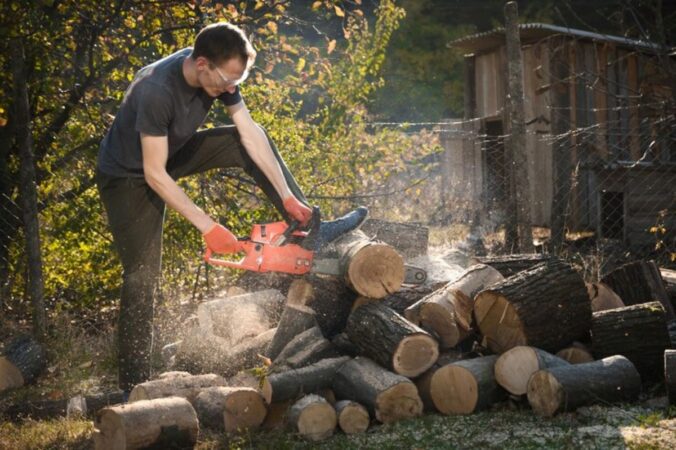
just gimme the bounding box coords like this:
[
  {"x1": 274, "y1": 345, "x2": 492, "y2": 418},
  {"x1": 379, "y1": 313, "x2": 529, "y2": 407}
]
[{"x1": 444, "y1": 23, "x2": 676, "y2": 248}]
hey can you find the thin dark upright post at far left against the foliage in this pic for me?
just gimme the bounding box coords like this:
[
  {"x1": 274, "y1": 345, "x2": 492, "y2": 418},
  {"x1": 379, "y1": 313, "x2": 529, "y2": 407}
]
[{"x1": 12, "y1": 38, "x2": 46, "y2": 340}]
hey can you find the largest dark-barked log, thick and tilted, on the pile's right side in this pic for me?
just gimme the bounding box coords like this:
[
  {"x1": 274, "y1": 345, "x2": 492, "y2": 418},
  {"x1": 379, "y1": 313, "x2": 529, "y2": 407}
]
[{"x1": 474, "y1": 259, "x2": 591, "y2": 353}]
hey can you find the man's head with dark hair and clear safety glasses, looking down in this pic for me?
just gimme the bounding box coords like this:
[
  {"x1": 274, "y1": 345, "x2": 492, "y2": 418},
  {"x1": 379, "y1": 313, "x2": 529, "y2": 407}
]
[{"x1": 190, "y1": 22, "x2": 256, "y2": 96}]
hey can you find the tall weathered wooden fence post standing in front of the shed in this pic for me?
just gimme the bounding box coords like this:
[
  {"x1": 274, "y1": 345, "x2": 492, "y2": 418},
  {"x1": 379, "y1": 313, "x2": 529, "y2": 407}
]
[{"x1": 505, "y1": 1, "x2": 533, "y2": 253}]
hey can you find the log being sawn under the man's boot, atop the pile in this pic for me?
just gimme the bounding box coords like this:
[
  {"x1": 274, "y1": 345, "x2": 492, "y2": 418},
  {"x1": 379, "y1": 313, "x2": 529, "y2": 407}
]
[{"x1": 334, "y1": 230, "x2": 405, "y2": 298}]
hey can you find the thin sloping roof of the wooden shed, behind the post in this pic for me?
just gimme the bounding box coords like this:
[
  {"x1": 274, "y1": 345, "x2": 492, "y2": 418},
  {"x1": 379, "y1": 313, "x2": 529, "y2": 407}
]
[{"x1": 447, "y1": 23, "x2": 659, "y2": 52}]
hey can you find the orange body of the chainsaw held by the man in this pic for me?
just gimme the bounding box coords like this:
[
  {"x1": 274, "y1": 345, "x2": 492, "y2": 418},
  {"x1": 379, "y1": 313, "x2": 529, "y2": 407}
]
[{"x1": 204, "y1": 222, "x2": 314, "y2": 275}]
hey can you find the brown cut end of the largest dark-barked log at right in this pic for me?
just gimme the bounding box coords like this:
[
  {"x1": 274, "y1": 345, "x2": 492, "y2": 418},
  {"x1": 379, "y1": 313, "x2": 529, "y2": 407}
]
[{"x1": 474, "y1": 291, "x2": 528, "y2": 353}]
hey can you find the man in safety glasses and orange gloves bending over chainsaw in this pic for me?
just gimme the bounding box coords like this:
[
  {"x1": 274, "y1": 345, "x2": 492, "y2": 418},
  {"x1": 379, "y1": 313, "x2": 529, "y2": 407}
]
[{"x1": 97, "y1": 23, "x2": 367, "y2": 392}]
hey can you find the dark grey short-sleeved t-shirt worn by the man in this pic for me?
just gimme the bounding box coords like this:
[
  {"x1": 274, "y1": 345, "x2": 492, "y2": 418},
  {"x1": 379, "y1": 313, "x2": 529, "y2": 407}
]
[{"x1": 98, "y1": 48, "x2": 242, "y2": 177}]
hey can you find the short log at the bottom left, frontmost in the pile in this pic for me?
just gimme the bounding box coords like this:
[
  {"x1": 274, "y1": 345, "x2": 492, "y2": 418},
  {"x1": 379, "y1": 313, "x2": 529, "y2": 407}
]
[{"x1": 94, "y1": 397, "x2": 199, "y2": 450}]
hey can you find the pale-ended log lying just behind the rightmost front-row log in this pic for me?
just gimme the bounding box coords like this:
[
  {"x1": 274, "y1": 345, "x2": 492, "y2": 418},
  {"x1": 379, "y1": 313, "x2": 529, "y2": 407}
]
[{"x1": 495, "y1": 345, "x2": 569, "y2": 395}]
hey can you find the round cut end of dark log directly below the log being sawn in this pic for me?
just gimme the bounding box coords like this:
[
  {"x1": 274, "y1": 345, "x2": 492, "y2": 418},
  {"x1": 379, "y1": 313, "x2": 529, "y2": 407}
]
[{"x1": 392, "y1": 333, "x2": 439, "y2": 377}]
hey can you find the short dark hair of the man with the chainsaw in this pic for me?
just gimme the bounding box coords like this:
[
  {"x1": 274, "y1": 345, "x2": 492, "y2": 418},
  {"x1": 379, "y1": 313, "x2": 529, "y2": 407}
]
[{"x1": 190, "y1": 22, "x2": 256, "y2": 70}]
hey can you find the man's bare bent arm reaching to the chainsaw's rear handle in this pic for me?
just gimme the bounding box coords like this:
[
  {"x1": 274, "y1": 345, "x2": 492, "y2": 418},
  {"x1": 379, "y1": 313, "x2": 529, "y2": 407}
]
[{"x1": 141, "y1": 133, "x2": 216, "y2": 234}]
